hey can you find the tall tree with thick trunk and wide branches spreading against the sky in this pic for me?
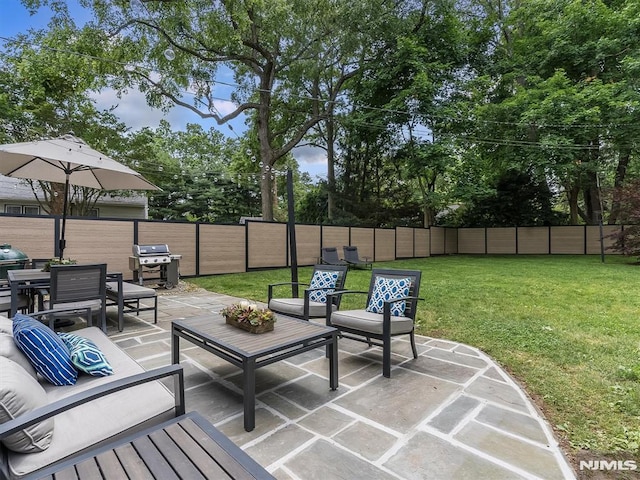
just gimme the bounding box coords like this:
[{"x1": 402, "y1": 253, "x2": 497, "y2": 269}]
[{"x1": 23, "y1": 0, "x2": 393, "y2": 220}]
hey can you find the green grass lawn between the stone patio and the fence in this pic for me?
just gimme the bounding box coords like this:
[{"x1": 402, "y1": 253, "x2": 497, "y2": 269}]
[{"x1": 190, "y1": 256, "x2": 640, "y2": 458}]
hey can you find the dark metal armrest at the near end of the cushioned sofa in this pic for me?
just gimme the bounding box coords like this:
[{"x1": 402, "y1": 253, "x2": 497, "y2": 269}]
[{"x1": 0, "y1": 364, "x2": 185, "y2": 439}]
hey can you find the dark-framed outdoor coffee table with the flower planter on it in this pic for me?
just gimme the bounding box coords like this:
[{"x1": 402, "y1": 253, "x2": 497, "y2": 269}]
[{"x1": 171, "y1": 314, "x2": 338, "y2": 432}]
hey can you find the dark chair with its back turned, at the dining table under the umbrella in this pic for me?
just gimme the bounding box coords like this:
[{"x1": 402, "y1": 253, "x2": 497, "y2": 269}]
[{"x1": 45, "y1": 263, "x2": 107, "y2": 333}]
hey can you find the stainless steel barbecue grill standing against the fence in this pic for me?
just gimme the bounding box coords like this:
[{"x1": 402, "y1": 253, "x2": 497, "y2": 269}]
[{"x1": 129, "y1": 244, "x2": 182, "y2": 288}]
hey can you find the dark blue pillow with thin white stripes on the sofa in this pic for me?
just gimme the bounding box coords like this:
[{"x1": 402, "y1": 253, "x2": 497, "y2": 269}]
[{"x1": 13, "y1": 313, "x2": 78, "y2": 385}]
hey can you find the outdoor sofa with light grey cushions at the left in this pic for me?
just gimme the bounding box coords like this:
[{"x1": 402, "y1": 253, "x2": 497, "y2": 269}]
[{"x1": 0, "y1": 315, "x2": 184, "y2": 479}]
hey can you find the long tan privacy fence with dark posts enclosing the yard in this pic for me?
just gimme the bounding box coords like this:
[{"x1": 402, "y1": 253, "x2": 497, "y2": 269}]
[{"x1": 0, "y1": 214, "x2": 623, "y2": 279}]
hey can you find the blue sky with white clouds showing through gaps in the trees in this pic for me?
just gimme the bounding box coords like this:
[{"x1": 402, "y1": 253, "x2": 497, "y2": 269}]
[{"x1": 0, "y1": 0, "x2": 327, "y2": 180}]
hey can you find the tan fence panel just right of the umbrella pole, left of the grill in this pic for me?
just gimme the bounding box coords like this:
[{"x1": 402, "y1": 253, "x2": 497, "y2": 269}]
[{"x1": 64, "y1": 219, "x2": 133, "y2": 280}]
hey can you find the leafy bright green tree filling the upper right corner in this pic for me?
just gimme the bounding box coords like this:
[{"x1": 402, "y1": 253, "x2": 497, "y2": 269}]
[{"x1": 462, "y1": 0, "x2": 640, "y2": 223}]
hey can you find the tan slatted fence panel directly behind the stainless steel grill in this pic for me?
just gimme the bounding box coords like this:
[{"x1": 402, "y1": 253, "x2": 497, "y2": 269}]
[{"x1": 138, "y1": 222, "x2": 196, "y2": 276}]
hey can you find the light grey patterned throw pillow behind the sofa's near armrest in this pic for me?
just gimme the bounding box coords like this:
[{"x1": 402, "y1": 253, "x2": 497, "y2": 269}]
[{"x1": 0, "y1": 357, "x2": 54, "y2": 453}]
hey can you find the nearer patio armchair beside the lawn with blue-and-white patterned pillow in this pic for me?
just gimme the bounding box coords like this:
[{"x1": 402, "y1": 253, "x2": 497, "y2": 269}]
[{"x1": 326, "y1": 269, "x2": 421, "y2": 378}]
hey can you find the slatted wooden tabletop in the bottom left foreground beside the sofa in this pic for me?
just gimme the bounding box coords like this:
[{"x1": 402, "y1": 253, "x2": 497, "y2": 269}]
[{"x1": 34, "y1": 412, "x2": 274, "y2": 480}]
